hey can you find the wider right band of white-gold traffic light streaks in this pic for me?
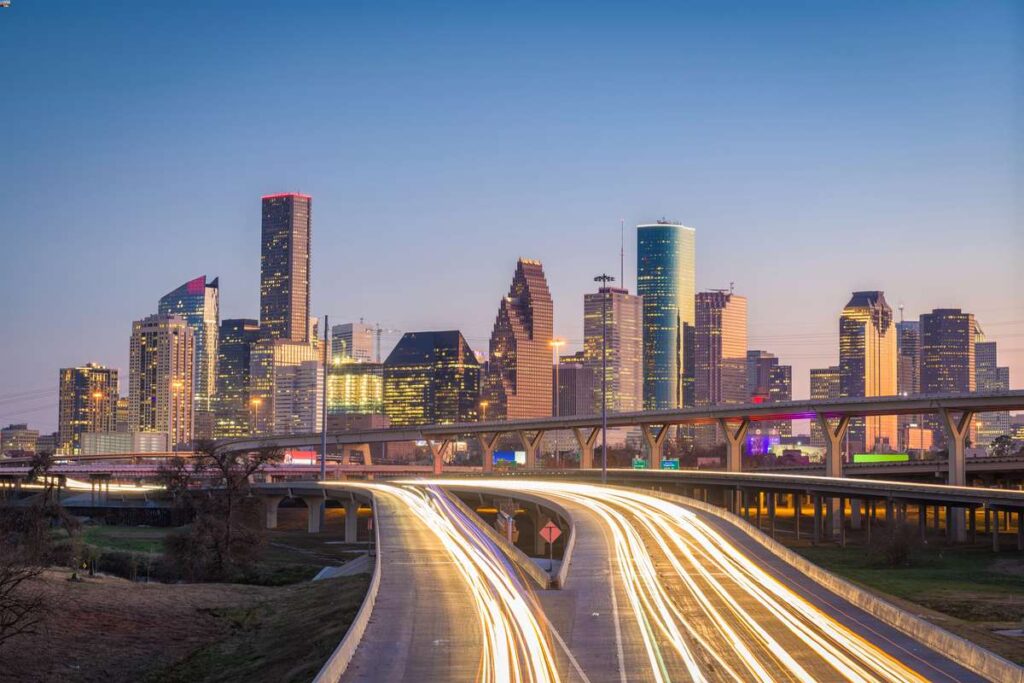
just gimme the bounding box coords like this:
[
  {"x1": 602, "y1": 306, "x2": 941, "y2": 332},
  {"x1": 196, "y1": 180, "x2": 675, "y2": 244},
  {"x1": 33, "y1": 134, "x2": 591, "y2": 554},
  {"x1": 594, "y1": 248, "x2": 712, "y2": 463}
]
[{"x1": 437, "y1": 480, "x2": 927, "y2": 682}]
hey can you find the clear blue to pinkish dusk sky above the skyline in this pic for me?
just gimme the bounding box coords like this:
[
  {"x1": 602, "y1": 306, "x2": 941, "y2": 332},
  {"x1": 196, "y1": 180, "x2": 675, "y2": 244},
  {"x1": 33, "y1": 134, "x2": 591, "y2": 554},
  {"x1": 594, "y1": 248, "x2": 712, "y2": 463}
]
[{"x1": 0, "y1": 0, "x2": 1024, "y2": 431}]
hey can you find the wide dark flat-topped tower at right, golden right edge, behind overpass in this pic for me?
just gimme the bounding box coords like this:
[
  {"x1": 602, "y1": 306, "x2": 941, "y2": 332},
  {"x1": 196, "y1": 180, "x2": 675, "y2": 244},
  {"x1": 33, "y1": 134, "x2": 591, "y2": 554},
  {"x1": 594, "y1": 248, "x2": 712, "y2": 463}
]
[{"x1": 921, "y1": 308, "x2": 978, "y2": 449}]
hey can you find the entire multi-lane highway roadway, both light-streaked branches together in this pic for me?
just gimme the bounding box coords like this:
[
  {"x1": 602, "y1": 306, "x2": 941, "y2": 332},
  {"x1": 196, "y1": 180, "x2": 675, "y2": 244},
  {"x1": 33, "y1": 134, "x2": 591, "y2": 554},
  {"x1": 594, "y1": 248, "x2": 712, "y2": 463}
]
[{"x1": 315, "y1": 479, "x2": 1011, "y2": 683}]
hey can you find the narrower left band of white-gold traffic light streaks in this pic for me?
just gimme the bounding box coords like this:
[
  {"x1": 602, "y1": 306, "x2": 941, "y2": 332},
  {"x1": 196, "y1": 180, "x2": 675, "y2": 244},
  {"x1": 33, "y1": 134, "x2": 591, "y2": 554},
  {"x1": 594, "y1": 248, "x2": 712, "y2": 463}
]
[{"x1": 352, "y1": 484, "x2": 558, "y2": 683}]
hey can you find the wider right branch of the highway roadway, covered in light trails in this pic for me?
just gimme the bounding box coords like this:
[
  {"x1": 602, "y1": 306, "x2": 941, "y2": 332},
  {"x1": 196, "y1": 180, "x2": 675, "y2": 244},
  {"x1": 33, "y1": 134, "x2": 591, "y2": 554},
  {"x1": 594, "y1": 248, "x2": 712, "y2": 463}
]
[{"x1": 434, "y1": 480, "x2": 983, "y2": 683}]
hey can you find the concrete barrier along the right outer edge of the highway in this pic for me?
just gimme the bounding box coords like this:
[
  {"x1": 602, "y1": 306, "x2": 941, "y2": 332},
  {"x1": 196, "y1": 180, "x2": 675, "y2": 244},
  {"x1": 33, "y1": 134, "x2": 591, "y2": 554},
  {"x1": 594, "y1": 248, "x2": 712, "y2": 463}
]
[{"x1": 643, "y1": 486, "x2": 1024, "y2": 683}]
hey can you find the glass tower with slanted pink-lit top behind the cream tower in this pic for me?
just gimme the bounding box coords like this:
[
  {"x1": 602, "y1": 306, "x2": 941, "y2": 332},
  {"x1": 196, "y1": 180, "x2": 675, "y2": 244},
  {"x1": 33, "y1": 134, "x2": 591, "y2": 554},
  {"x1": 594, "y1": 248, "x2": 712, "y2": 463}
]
[{"x1": 157, "y1": 275, "x2": 220, "y2": 438}]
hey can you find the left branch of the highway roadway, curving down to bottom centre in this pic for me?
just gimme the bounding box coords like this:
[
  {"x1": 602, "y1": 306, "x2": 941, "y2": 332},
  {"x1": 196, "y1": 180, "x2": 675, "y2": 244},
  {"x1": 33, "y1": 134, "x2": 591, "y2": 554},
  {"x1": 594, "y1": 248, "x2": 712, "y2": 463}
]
[{"x1": 329, "y1": 484, "x2": 558, "y2": 683}]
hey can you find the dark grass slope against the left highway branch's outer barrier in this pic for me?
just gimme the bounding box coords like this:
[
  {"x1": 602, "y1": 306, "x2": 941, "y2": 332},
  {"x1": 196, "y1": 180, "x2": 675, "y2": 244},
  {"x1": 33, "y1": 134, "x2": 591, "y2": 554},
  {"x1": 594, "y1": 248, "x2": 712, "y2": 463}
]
[{"x1": 142, "y1": 575, "x2": 370, "y2": 683}]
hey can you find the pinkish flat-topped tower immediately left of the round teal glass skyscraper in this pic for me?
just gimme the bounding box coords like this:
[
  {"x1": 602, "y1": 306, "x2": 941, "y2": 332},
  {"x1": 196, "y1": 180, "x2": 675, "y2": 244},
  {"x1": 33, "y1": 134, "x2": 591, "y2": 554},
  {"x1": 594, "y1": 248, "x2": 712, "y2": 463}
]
[{"x1": 585, "y1": 287, "x2": 643, "y2": 413}]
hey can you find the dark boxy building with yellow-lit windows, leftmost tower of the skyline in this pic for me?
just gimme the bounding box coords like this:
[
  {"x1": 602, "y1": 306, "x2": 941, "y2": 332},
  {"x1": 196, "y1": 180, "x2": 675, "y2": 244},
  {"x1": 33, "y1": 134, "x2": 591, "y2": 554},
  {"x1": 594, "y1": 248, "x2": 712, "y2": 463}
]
[{"x1": 57, "y1": 362, "x2": 119, "y2": 455}]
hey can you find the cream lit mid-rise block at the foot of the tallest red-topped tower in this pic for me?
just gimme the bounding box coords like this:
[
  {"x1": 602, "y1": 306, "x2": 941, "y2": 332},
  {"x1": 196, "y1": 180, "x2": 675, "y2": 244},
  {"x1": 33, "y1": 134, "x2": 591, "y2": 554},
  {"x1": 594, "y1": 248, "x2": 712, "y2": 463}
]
[{"x1": 249, "y1": 333, "x2": 324, "y2": 434}]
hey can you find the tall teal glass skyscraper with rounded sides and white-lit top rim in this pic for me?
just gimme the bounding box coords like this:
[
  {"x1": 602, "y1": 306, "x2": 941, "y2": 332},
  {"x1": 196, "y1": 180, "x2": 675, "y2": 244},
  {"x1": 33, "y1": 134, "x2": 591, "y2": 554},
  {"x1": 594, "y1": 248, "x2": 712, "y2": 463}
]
[{"x1": 637, "y1": 221, "x2": 696, "y2": 411}]
